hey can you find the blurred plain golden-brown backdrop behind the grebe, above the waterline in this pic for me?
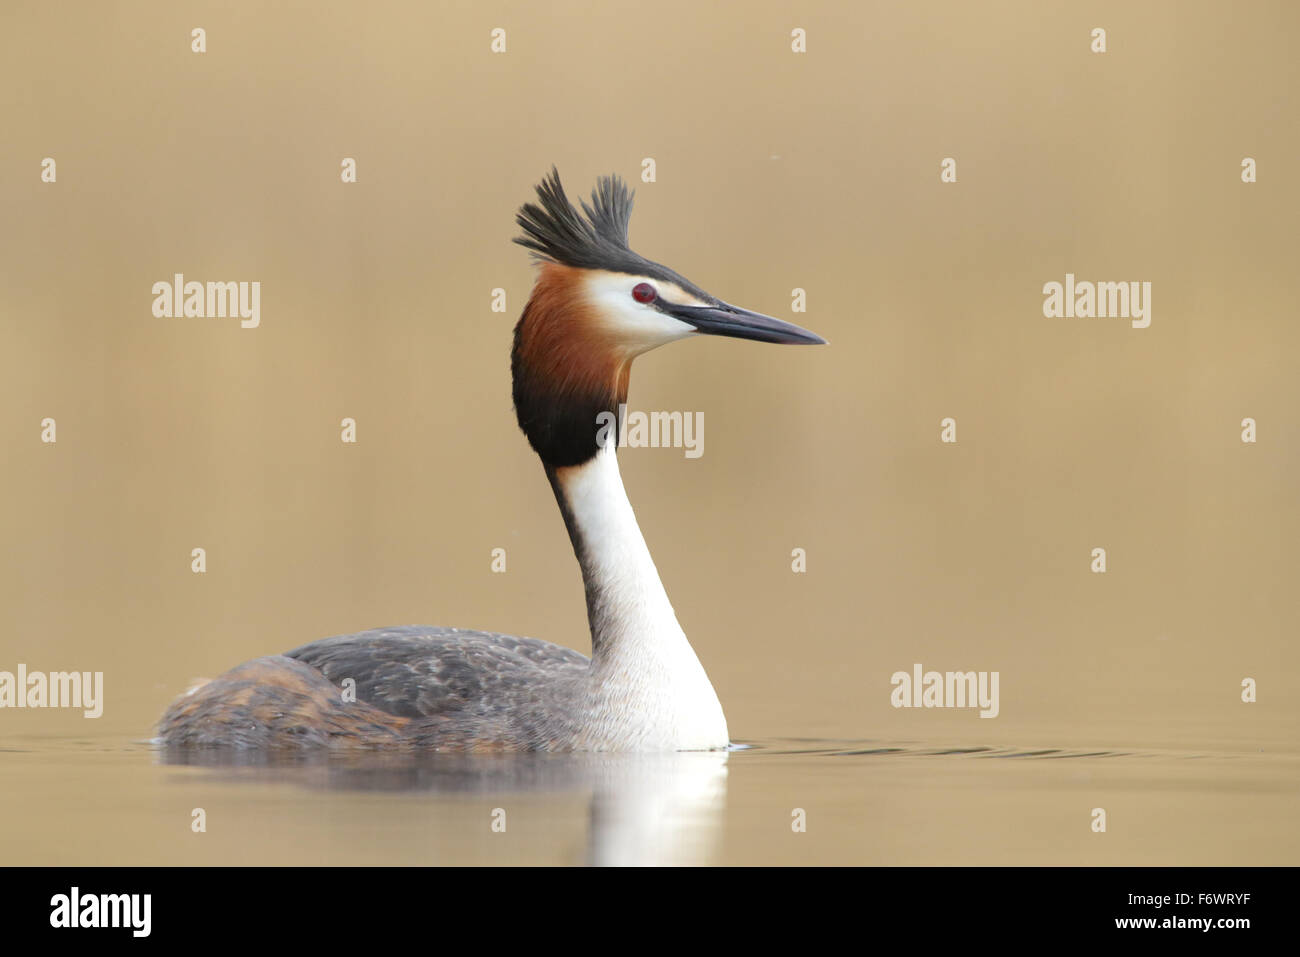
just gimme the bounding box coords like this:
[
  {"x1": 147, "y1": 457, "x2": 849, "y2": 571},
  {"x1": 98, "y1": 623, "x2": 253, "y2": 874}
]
[{"x1": 0, "y1": 1, "x2": 1300, "y2": 862}]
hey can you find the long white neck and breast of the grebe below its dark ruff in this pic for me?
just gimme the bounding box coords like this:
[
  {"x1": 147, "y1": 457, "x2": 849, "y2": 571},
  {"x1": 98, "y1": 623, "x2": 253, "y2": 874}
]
[{"x1": 551, "y1": 443, "x2": 729, "y2": 750}]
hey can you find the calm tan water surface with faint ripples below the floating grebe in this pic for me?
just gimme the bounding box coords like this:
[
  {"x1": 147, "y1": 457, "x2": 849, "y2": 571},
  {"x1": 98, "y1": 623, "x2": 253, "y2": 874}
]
[{"x1": 0, "y1": 737, "x2": 1300, "y2": 865}]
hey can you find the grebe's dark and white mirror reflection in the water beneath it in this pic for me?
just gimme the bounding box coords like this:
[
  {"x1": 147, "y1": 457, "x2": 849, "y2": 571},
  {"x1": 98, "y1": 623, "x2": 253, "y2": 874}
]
[{"x1": 160, "y1": 750, "x2": 728, "y2": 866}]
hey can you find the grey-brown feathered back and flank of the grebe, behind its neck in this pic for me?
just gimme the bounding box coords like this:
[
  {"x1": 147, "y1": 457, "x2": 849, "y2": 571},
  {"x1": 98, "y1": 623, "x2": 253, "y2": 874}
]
[{"x1": 159, "y1": 625, "x2": 590, "y2": 750}]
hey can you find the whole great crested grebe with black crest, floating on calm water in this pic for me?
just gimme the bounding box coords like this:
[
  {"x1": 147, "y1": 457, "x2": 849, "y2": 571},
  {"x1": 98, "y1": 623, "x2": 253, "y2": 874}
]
[{"x1": 159, "y1": 168, "x2": 824, "y2": 752}]
